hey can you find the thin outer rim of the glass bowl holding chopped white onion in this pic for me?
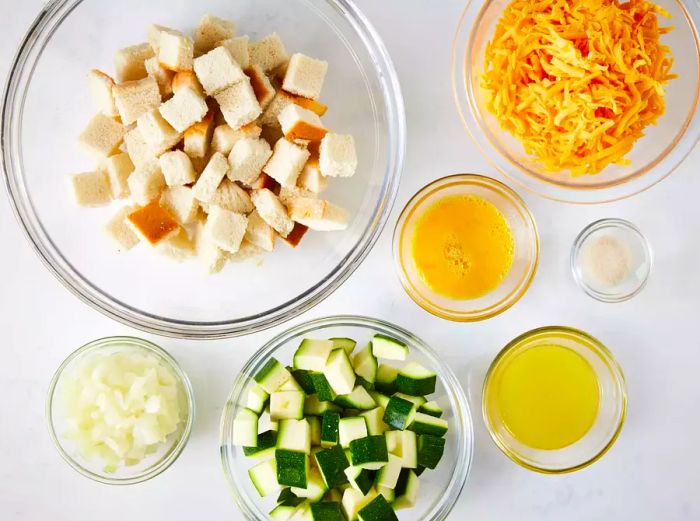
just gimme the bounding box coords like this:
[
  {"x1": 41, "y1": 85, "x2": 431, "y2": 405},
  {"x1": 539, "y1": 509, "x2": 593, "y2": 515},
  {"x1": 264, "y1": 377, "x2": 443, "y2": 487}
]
[{"x1": 45, "y1": 336, "x2": 196, "y2": 485}]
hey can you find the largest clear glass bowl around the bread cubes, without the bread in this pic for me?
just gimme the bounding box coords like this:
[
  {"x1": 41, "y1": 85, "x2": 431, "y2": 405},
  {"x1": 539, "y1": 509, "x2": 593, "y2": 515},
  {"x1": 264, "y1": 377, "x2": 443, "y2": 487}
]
[{"x1": 2, "y1": 0, "x2": 406, "y2": 338}]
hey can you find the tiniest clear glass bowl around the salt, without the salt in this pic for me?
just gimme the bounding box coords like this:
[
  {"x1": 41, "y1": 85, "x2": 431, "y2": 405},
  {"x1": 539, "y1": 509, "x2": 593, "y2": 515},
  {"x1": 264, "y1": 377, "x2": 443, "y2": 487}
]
[{"x1": 571, "y1": 219, "x2": 654, "y2": 302}]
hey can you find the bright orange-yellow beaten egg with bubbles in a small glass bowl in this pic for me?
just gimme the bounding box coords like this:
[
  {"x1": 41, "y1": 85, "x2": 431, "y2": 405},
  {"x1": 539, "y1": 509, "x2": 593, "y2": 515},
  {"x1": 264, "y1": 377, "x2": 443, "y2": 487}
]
[{"x1": 411, "y1": 195, "x2": 514, "y2": 300}]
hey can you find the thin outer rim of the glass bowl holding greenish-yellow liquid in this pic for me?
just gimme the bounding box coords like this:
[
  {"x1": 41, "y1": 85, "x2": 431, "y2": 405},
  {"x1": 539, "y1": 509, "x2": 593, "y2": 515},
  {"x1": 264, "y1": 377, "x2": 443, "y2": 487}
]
[{"x1": 481, "y1": 326, "x2": 627, "y2": 474}]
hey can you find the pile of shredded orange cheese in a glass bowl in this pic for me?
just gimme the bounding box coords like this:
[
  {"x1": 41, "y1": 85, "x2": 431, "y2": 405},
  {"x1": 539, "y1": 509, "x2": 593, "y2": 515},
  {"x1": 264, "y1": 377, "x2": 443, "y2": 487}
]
[{"x1": 482, "y1": 0, "x2": 676, "y2": 176}]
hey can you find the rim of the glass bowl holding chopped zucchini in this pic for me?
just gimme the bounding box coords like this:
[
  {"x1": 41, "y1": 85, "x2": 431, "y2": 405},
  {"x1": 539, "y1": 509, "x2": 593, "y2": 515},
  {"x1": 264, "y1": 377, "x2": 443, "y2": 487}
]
[{"x1": 219, "y1": 315, "x2": 474, "y2": 521}]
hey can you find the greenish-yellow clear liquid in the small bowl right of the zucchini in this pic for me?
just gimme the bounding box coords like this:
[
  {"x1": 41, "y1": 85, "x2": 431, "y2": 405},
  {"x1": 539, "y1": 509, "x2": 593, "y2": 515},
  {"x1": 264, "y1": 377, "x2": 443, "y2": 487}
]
[{"x1": 486, "y1": 345, "x2": 600, "y2": 450}]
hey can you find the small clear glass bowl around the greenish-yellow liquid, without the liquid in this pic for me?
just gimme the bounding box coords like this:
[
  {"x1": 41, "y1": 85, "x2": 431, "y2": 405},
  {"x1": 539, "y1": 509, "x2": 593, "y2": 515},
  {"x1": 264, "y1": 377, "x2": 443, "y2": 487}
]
[{"x1": 482, "y1": 326, "x2": 627, "y2": 474}]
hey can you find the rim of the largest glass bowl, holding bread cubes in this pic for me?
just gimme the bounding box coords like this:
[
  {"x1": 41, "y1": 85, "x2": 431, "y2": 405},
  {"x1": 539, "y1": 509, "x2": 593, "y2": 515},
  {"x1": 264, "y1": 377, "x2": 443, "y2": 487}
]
[{"x1": 0, "y1": 0, "x2": 406, "y2": 339}]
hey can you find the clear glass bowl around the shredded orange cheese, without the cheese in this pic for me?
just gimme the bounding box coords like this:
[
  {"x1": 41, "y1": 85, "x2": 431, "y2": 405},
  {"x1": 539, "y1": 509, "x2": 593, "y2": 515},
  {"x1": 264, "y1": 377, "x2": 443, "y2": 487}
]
[{"x1": 452, "y1": 0, "x2": 700, "y2": 204}]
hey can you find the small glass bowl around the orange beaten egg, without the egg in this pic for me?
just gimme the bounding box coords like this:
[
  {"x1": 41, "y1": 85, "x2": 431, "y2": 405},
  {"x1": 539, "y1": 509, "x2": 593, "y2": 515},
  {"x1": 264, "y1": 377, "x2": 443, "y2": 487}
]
[{"x1": 393, "y1": 174, "x2": 540, "y2": 322}]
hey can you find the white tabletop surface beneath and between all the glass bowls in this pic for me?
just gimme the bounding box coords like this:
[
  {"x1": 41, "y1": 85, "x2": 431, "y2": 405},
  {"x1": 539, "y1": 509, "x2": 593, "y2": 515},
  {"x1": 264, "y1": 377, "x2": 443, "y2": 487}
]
[{"x1": 0, "y1": 0, "x2": 700, "y2": 521}]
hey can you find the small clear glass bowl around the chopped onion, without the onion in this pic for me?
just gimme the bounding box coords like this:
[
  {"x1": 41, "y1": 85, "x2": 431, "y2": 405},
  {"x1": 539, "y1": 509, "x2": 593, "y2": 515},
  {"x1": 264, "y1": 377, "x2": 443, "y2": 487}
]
[{"x1": 46, "y1": 336, "x2": 195, "y2": 485}]
